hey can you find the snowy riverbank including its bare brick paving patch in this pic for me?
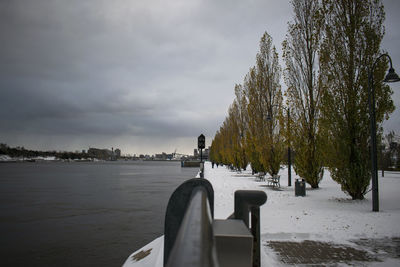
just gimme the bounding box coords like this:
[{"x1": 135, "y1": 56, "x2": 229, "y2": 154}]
[{"x1": 124, "y1": 162, "x2": 400, "y2": 266}]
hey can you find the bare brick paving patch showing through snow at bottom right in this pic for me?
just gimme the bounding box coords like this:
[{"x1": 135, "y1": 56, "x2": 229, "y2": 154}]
[{"x1": 264, "y1": 237, "x2": 400, "y2": 266}]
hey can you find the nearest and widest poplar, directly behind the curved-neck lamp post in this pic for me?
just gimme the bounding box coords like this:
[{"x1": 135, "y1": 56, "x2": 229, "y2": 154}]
[{"x1": 320, "y1": 0, "x2": 394, "y2": 199}]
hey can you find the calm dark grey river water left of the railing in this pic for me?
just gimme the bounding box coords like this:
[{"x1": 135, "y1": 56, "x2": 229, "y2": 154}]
[{"x1": 0, "y1": 162, "x2": 197, "y2": 266}]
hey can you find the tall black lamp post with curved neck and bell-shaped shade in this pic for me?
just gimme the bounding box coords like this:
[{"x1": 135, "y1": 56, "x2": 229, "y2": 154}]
[{"x1": 368, "y1": 54, "x2": 400, "y2": 214}]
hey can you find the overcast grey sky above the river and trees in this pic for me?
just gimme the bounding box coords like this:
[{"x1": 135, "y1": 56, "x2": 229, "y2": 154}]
[{"x1": 0, "y1": 0, "x2": 400, "y2": 154}]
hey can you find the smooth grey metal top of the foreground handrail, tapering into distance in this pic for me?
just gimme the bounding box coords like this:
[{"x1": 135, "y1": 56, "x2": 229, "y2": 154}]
[{"x1": 167, "y1": 186, "x2": 219, "y2": 267}]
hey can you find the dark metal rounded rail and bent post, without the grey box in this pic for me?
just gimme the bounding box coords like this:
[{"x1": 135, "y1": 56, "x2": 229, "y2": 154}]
[{"x1": 164, "y1": 178, "x2": 267, "y2": 267}]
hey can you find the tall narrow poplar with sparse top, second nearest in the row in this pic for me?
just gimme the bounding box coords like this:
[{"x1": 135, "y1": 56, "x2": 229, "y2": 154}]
[{"x1": 282, "y1": 0, "x2": 323, "y2": 188}]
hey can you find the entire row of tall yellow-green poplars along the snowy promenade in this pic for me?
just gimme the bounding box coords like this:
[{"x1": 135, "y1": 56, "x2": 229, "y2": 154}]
[{"x1": 210, "y1": 0, "x2": 394, "y2": 199}]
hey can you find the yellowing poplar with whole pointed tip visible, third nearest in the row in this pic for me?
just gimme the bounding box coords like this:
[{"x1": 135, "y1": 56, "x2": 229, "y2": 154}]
[{"x1": 246, "y1": 32, "x2": 284, "y2": 175}]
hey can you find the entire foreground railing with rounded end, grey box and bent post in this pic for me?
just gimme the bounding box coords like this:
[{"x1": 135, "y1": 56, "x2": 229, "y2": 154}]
[{"x1": 164, "y1": 178, "x2": 267, "y2": 267}]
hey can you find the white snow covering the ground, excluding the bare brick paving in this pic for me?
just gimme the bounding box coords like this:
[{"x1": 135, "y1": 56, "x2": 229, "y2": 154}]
[{"x1": 124, "y1": 162, "x2": 400, "y2": 266}]
